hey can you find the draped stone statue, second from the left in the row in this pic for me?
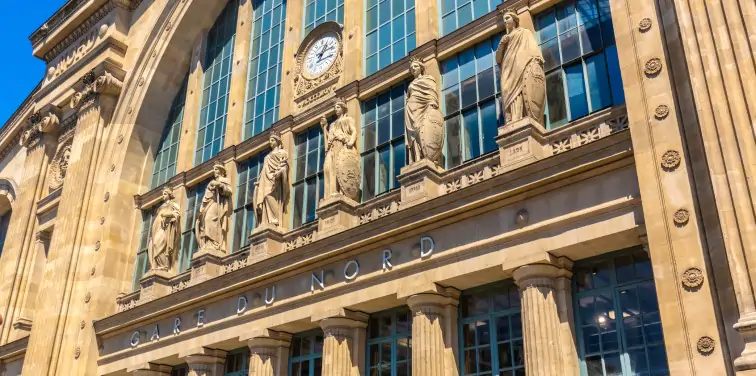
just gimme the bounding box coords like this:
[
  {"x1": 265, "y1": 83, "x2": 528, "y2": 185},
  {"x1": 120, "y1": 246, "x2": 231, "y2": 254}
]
[{"x1": 194, "y1": 162, "x2": 231, "y2": 252}]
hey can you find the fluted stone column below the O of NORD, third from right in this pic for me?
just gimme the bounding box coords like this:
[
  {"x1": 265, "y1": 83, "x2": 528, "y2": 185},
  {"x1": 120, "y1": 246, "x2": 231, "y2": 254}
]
[{"x1": 320, "y1": 311, "x2": 368, "y2": 376}]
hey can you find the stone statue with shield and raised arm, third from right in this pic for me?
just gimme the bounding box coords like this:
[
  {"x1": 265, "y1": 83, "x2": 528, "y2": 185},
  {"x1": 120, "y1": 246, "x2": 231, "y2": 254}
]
[{"x1": 320, "y1": 99, "x2": 360, "y2": 201}]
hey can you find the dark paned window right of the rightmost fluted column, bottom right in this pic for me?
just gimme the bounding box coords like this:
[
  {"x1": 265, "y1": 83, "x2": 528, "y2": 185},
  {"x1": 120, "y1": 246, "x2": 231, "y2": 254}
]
[{"x1": 573, "y1": 249, "x2": 669, "y2": 376}]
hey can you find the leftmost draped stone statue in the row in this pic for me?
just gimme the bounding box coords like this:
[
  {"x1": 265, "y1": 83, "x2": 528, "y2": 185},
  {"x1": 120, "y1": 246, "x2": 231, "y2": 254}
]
[{"x1": 147, "y1": 188, "x2": 181, "y2": 271}]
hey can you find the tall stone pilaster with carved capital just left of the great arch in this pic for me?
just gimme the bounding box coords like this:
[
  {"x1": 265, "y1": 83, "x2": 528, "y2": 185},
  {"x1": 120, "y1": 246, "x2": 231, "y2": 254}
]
[{"x1": 24, "y1": 65, "x2": 123, "y2": 375}]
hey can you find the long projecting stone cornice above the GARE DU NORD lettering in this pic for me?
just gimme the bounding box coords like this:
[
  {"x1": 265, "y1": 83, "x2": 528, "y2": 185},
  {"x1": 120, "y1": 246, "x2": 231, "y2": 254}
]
[{"x1": 94, "y1": 131, "x2": 639, "y2": 337}]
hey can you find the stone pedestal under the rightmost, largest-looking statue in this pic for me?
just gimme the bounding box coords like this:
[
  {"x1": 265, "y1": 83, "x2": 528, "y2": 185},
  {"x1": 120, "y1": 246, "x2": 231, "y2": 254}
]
[{"x1": 496, "y1": 117, "x2": 547, "y2": 172}]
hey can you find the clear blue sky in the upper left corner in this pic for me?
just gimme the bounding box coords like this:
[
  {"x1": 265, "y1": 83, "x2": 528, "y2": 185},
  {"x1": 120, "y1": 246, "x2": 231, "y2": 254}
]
[{"x1": 0, "y1": 0, "x2": 66, "y2": 126}]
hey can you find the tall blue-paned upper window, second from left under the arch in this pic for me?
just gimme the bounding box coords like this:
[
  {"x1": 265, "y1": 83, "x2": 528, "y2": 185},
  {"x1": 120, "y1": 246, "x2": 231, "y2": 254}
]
[{"x1": 194, "y1": 0, "x2": 239, "y2": 165}]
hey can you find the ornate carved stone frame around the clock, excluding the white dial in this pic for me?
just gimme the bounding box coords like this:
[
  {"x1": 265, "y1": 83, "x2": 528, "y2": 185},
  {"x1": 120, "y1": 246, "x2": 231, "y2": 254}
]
[{"x1": 293, "y1": 21, "x2": 344, "y2": 110}]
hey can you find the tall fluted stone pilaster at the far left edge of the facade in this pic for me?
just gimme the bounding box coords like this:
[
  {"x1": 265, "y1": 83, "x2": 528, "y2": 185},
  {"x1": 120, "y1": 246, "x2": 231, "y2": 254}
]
[{"x1": 0, "y1": 111, "x2": 59, "y2": 344}]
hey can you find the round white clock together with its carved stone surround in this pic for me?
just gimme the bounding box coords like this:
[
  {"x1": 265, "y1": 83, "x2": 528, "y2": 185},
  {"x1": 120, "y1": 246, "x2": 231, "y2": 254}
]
[{"x1": 293, "y1": 22, "x2": 344, "y2": 108}]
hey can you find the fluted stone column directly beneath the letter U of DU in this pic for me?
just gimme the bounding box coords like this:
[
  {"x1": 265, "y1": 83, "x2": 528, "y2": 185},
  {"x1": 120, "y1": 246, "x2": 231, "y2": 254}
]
[{"x1": 247, "y1": 330, "x2": 291, "y2": 376}]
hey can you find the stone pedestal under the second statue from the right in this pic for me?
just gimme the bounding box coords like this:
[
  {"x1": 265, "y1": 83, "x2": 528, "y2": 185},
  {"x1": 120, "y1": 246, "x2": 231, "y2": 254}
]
[{"x1": 397, "y1": 159, "x2": 444, "y2": 206}]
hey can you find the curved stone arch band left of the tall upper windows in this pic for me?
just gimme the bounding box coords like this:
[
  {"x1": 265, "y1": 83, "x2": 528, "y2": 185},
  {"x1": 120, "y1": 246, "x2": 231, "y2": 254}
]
[{"x1": 91, "y1": 0, "x2": 249, "y2": 294}]
